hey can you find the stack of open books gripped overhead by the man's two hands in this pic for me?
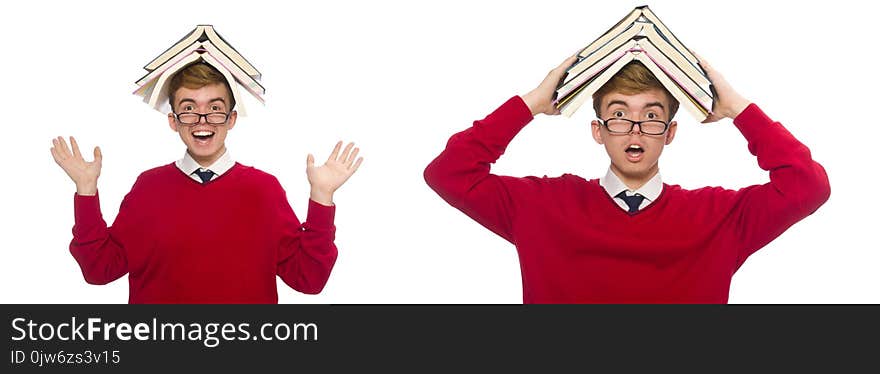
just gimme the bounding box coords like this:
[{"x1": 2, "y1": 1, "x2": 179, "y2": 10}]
[{"x1": 554, "y1": 6, "x2": 715, "y2": 121}]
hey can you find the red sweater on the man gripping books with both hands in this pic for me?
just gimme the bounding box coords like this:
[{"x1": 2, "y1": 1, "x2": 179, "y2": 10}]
[{"x1": 425, "y1": 97, "x2": 830, "y2": 303}]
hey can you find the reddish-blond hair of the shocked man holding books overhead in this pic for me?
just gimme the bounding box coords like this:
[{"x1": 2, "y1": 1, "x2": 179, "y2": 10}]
[{"x1": 593, "y1": 61, "x2": 678, "y2": 120}]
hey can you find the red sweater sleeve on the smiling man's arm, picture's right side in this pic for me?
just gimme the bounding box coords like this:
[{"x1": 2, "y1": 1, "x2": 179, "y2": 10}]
[{"x1": 277, "y1": 185, "x2": 337, "y2": 294}]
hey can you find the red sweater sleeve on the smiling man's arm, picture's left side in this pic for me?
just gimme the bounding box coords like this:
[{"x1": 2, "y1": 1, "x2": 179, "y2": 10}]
[{"x1": 70, "y1": 194, "x2": 131, "y2": 284}]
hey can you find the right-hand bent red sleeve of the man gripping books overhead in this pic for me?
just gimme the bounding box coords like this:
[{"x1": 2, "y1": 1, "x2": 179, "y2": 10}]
[{"x1": 734, "y1": 104, "x2": 831, "y2": 266}]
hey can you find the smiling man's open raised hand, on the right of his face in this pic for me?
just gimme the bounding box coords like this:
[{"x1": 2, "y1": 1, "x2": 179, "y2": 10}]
[{"x1": 306, "y1": 141, "x2": 364, "y2": 205}]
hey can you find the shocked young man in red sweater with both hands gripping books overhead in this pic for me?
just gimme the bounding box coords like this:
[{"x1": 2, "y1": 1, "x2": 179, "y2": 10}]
[{"x1": 425, "y1": 56, "x2": 830, "y2": 303}]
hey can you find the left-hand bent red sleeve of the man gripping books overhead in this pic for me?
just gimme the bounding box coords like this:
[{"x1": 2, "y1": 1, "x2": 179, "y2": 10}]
[{"x1": 424, "y1": 96, "x2": 534, "y2": 242}]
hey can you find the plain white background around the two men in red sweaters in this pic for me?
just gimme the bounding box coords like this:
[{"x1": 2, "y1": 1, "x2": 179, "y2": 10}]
[{"x1": 0, "y1": 0, "x2": 880, "y2": 303}]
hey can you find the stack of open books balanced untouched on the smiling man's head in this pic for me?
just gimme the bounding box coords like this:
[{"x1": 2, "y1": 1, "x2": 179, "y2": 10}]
[{"x1": 134, "y1": 25, "x2": 266, "y2": 115}]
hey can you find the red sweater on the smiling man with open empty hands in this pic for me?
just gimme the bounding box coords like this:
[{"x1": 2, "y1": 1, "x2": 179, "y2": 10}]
[{"x1": 70, "y1": 163, "x2": 337, "y2": 303}]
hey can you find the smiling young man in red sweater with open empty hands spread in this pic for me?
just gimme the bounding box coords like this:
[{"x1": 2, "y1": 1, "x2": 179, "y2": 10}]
[{"x1": 51, "y1": 63, "x2": 363, "y2": 303}]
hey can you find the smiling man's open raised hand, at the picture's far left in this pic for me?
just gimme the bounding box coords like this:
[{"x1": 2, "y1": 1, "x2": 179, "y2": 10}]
[{"x1": 49, "y1": 136, "x2": 101, "y2": 196}]
